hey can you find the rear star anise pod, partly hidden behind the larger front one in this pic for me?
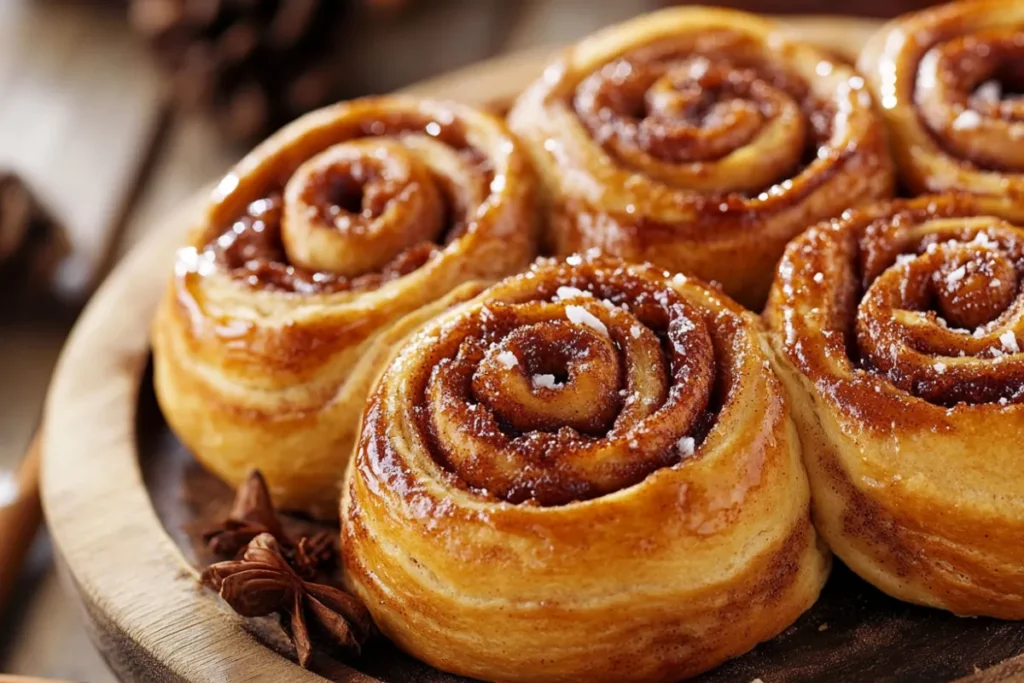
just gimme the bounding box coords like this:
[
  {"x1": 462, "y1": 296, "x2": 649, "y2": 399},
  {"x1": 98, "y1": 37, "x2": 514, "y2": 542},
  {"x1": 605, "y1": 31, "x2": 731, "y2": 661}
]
[{"x1": 203, "y1": 470, "x2": 338, "y2": 580}]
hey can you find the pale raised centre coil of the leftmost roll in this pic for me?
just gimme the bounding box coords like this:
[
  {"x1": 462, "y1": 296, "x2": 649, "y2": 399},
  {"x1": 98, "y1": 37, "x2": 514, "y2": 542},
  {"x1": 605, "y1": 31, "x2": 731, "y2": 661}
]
[{"x1": 281, "y1": 139, "x2": 445, "y2": 276}]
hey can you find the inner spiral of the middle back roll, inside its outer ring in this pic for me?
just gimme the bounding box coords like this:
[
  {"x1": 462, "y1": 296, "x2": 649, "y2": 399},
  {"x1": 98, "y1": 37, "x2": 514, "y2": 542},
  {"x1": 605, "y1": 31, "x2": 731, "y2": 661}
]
[{"x1": 573, "y1": 46, "x2": 807, "y2": 193}]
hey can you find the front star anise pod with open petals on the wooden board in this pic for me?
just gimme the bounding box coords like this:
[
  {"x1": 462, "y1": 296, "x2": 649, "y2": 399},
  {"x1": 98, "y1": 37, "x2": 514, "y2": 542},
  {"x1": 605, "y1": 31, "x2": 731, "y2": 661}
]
[{"x1": 201, "y1": 533, "x2": 373, "y2": 667}]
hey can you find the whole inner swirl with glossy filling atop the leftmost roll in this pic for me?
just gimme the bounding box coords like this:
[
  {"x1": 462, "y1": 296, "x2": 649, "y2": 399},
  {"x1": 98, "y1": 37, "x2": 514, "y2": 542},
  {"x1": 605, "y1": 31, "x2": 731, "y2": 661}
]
[{"x1": 205, "y1": 116, "x2": 495, "y2": 293}]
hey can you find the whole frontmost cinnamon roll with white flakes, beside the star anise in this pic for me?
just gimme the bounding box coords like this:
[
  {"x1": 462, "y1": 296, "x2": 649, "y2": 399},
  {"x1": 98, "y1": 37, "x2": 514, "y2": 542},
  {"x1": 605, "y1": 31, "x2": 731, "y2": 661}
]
[{"x1": 342, "y1": 256, "x2": 828, "y2": 681}]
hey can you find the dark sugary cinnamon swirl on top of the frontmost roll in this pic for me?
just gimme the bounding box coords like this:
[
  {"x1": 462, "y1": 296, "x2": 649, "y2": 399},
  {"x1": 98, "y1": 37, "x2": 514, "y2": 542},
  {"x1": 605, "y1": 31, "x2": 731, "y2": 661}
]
[{"x1": 387, "y1": 261, "x2": 742, "y2": 506}]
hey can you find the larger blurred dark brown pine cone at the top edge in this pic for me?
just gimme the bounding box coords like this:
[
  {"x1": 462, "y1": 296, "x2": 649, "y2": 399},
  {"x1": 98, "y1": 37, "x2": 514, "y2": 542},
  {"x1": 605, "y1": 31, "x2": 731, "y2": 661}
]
[{"x1": 131, "y1": 0, "x2": 352, "y2": 143}]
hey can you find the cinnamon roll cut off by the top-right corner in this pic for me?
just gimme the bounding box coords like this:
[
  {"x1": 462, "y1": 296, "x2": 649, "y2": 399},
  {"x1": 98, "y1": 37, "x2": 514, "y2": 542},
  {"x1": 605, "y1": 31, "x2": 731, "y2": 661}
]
[{"x1": 859, "y1": 0, "x2": 1024, "y2": 218}]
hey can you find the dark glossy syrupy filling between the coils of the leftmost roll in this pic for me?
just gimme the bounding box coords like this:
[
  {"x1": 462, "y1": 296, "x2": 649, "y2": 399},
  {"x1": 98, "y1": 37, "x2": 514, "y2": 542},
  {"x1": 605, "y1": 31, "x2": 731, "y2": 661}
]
[{"x1": 204, "y1": 116, "x2": 494, "y2": 294}]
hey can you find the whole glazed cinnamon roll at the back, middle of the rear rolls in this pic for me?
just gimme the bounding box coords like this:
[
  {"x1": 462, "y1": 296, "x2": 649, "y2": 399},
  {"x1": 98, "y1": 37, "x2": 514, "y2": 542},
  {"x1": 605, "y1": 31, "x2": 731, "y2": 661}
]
[{"x1": 509, "y1": 7, "x2": 893, "y2": 307}]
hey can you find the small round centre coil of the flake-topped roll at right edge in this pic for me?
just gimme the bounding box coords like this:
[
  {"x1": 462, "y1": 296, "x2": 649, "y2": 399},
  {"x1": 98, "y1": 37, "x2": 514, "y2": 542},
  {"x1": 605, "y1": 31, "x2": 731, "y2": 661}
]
[{"x1": 932, "y1": 242, "x2": 1017, "y2": 330}]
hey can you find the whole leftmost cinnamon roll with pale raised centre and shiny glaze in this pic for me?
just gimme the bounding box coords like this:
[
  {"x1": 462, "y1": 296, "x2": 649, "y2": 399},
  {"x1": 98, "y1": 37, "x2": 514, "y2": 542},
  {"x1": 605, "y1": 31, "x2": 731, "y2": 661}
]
[{"x1": 154, "y1": 96, "x2": 536, "y2": 516}]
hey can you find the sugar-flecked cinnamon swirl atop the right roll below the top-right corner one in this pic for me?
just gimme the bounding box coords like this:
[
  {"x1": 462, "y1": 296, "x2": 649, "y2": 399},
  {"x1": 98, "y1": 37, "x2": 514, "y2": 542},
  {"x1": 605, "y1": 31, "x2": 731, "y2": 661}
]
[{"x1": 851, "y1": 207, "x2": 1024, "y2": 405}]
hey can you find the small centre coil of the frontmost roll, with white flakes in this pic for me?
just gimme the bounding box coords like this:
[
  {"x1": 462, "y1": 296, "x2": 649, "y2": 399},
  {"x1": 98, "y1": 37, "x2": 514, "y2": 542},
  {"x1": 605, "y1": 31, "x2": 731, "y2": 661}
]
[{"x1": 473, "y1": 322, "x2": 620, "y2": 434}]
